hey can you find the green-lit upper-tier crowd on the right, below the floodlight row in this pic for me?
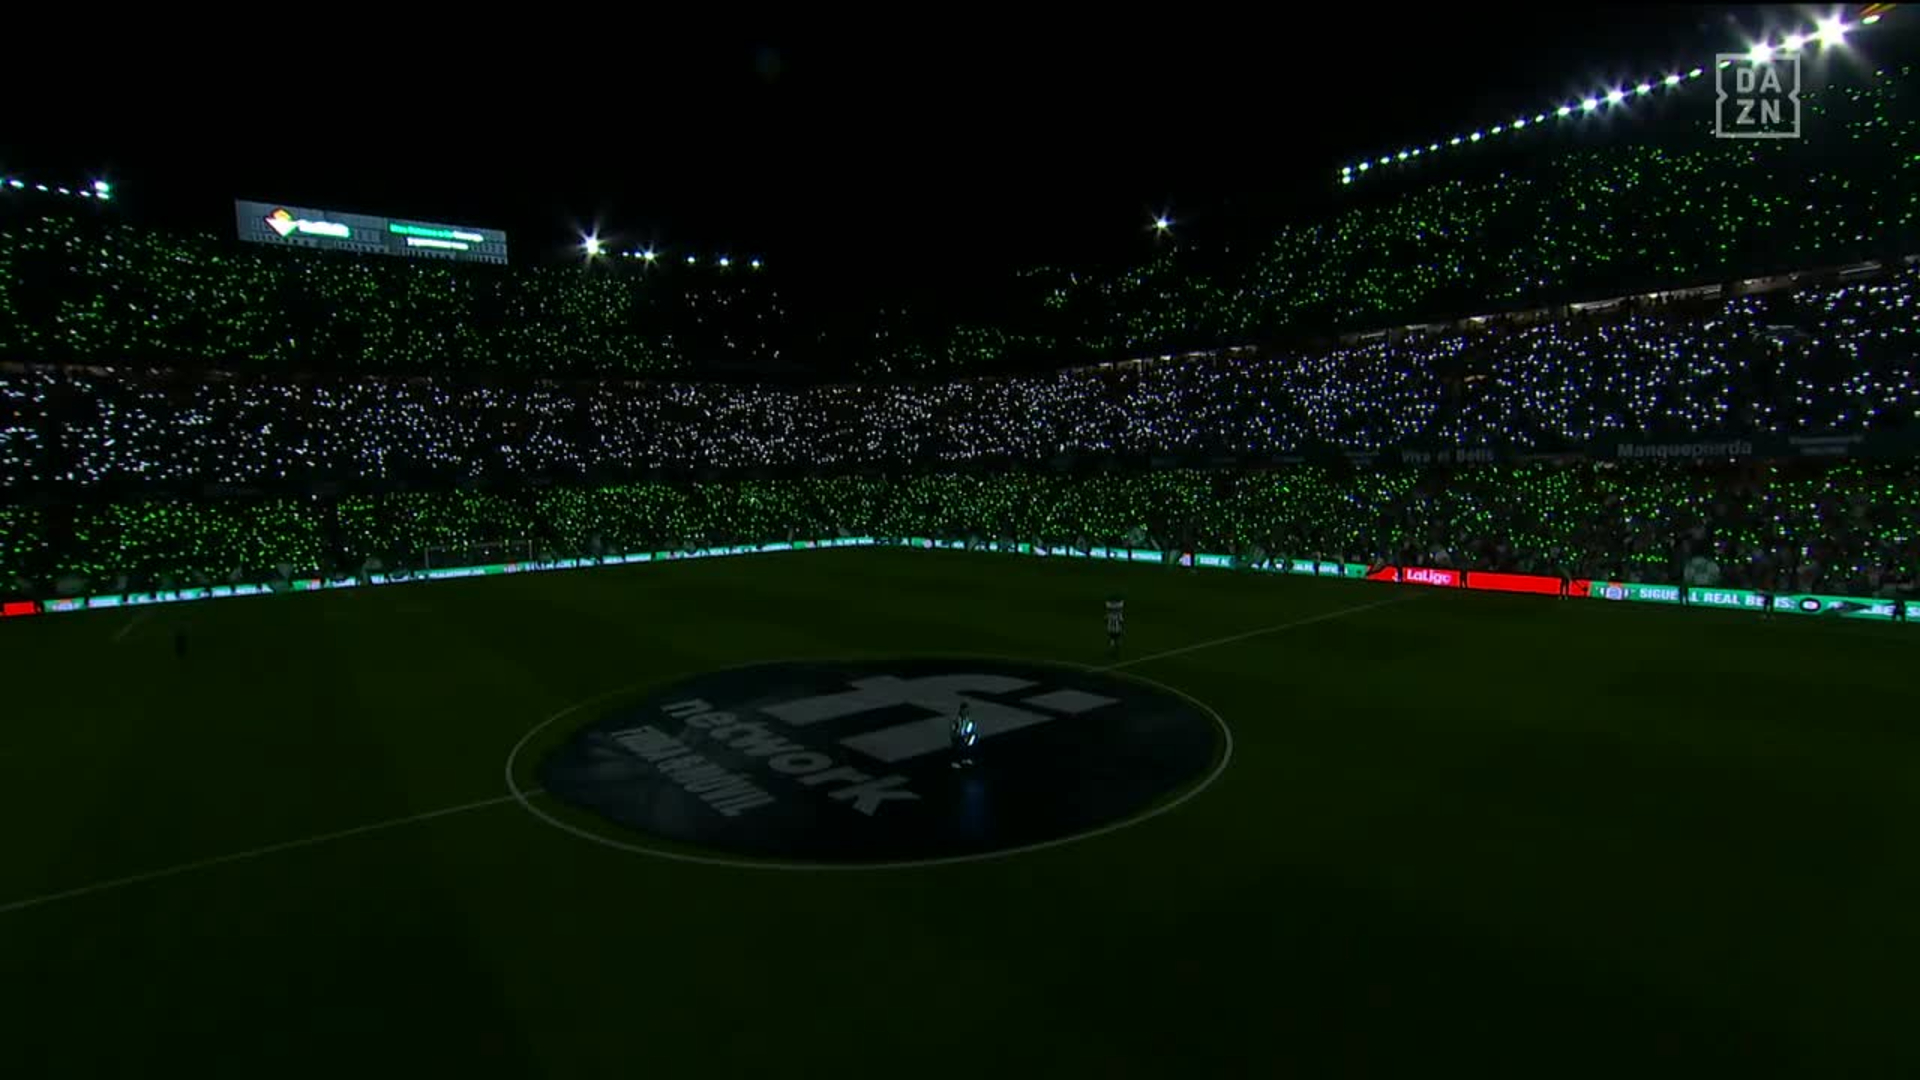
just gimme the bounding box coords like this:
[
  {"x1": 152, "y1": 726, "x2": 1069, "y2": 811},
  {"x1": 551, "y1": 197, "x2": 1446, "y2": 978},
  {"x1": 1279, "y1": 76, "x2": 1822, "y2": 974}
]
[{"x1": 872, "y1": 67, "x2": 1920, "y2": 375}]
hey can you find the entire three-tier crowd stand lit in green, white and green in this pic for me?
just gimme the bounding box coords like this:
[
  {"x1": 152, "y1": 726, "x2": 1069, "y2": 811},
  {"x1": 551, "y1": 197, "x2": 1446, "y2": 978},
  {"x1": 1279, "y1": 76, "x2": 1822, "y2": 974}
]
[{"x1": 0, "y1": 69, "x2": 1920, "y2": 596}]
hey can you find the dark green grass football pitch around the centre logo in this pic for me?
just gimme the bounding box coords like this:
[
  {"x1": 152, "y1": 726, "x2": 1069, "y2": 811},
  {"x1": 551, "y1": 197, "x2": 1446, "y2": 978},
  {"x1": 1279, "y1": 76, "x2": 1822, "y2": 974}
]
[{"x1": 0, "y1": 550, "x2": 1920, "y2": 1078}]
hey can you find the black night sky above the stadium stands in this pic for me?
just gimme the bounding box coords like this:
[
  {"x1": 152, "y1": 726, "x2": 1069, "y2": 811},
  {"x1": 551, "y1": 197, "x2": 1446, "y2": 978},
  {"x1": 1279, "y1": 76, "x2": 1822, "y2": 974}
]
[{"x1": 0, "y1": 4, "x2": 1889, "y2": 303}]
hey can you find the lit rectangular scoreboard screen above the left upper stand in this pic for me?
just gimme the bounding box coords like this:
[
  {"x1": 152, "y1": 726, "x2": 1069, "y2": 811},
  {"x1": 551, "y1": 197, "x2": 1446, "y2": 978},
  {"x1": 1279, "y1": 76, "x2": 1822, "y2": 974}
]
[{"x1": 234, "y1": 198, "x2": 507, "y2": 265}]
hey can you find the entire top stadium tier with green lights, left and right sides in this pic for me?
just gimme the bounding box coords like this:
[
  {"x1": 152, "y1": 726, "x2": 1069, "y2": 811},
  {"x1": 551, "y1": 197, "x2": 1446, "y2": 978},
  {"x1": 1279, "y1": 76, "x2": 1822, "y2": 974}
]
[{"x1": 0, "y1": 67, "x2": 1920, "y2": 377}]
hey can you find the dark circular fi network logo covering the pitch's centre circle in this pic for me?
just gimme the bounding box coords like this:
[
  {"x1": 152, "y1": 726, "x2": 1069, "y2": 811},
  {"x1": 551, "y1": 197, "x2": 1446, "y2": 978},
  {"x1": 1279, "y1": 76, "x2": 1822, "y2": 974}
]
[{"x1": 540, "y1": 659, "x2": 1227, "y2": 863}]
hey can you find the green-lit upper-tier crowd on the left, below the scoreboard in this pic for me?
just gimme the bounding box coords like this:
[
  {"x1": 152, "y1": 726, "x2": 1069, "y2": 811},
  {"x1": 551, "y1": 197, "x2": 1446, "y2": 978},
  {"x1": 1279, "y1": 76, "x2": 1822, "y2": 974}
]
[{"x1": 0, "y1": 213, "x2": 787, "y2": 377}]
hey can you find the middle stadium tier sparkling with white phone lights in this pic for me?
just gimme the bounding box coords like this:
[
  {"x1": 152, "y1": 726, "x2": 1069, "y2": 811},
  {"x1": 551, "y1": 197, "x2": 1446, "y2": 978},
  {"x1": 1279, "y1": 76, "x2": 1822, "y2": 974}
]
[{"x1": 0, "y1": 265, "x2": 1920, "y2": 494}]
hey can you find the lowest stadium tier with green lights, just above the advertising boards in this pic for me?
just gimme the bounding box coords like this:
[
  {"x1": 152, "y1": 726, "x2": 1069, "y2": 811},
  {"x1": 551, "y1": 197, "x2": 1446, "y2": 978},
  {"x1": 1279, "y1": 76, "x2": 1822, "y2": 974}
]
[{"x1": 0, "y1": 461, "x2": 1920, "y2": 600}]
